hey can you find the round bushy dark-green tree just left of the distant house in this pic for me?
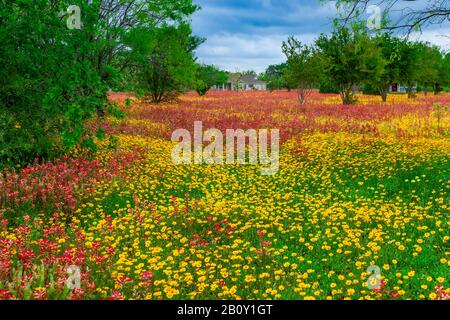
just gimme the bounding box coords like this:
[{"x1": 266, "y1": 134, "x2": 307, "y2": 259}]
[{"x1": 128, "y1": 24, "x2": 201, "y2": 103}]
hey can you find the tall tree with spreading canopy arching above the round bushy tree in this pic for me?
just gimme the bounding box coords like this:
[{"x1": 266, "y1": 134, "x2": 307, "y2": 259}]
[{"x1": 60, "y1": 0, "x2": 200, "y2": 115}]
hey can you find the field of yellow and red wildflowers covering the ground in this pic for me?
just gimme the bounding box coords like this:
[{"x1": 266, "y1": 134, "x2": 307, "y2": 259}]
[{"x1": 0, "y1": 91, "x2": 450, "y2": 300}]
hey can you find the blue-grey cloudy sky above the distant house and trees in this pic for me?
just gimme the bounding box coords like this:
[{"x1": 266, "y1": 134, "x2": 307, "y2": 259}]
[{"x1": 192, "y1": 0, "x2": 450, "y2": 72}]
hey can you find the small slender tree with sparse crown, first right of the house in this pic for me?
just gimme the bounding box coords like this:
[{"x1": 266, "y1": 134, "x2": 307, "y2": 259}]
[{"x1": 282, "y1": 37, "x2": 321, "y2": 105}]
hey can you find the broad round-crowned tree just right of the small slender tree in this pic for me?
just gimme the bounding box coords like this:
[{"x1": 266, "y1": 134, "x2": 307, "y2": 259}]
[{"x1": 316, "y1": 24, "x2": 384, "y2": 104}]
